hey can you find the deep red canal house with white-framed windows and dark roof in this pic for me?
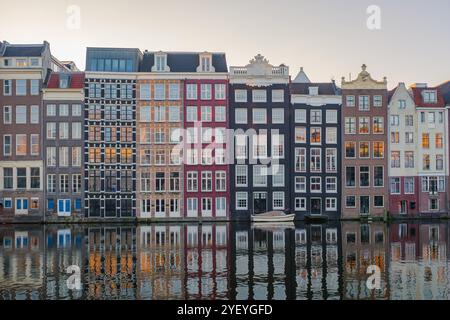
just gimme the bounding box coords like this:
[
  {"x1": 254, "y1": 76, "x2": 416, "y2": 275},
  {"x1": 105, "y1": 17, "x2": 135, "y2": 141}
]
[{"x1": 181, "y1": 52, "x2": 230, "y2": 219}]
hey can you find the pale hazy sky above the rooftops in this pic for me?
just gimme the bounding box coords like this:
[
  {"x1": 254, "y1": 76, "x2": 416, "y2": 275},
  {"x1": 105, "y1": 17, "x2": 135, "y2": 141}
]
[{"x1": 0, "y1": 0, "x2": 450, "y2": 88}]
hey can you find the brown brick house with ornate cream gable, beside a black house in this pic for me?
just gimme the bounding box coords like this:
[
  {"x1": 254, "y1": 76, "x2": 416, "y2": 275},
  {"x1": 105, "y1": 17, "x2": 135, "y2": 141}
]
[{"x1": 341, "y1": 65, "x2": 389, "y2": 218}]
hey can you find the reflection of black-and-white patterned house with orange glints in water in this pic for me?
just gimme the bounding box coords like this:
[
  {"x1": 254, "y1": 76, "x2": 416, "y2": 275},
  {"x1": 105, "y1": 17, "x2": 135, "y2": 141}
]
[{"x1": 84, "y1": 226, "x2": 136, "y2": 299}]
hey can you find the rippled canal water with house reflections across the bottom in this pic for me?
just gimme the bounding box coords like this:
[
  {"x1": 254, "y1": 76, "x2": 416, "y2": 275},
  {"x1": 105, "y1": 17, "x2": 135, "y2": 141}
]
[{"x1": 0, "y1": 221, "x2": 450, "y2": 300}]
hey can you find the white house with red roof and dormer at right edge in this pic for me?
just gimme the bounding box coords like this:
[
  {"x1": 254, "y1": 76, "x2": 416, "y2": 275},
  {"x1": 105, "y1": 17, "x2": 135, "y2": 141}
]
[{"x1": 411, "y1": 84, "x2": 449, "y2": 217}]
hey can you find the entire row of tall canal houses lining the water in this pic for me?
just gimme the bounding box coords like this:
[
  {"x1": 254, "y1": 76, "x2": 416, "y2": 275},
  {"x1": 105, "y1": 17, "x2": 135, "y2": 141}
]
[{"x1": 0, "y1": 42, "x2": 450, "y2": 222}]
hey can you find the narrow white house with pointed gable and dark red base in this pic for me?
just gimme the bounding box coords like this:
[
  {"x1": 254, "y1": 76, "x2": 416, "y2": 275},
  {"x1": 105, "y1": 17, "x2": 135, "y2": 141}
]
[{"x1": 388, "y1": 83, "x2": 420, "y2": 217}]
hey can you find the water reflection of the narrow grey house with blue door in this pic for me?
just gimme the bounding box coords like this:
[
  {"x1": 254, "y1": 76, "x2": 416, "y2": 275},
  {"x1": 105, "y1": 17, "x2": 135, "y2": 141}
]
[{"x1": 44, "y1": 226, "x2": 86, "y2": 299}]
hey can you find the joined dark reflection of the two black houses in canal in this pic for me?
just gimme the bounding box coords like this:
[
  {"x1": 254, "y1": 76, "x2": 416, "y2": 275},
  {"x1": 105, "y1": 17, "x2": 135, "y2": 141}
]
[{"x1": 231, "y1": 224, "x2": 340, "y2": 299}]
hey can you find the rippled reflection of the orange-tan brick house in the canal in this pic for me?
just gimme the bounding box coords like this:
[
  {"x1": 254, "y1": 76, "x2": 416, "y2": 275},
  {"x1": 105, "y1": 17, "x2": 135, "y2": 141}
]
[{"x1": 136, "y1": 225, "x2": 184, "y2": 300}]
